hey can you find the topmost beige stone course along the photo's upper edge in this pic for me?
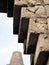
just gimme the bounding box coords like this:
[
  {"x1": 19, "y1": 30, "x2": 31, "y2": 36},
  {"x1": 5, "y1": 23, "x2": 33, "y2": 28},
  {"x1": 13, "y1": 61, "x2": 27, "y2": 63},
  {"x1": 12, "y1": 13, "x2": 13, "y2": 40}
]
[{"x1": 14, "y1": 0, "x2": 49, "y2": 6}]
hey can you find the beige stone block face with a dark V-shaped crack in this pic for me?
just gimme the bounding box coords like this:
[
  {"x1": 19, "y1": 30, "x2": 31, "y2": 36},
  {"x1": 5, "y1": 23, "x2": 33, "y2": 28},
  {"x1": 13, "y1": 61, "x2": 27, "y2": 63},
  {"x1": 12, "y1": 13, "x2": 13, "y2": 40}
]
[{"x1": 21, "y1": 5, "x2": 49, "y2": 18}]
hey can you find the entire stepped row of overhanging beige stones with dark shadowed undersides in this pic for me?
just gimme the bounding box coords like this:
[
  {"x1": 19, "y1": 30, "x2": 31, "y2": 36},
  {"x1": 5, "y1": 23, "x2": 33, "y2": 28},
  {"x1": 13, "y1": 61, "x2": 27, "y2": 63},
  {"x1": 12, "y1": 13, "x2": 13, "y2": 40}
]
[{"x1": 0, "y1": 0, "x2": 49, "y2": 65}]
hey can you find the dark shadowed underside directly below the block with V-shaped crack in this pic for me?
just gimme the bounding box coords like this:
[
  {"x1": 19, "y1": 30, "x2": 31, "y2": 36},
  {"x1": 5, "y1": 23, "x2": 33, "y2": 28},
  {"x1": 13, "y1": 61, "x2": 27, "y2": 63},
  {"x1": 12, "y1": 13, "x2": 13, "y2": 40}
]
[{"x1": 18, "y1": 17, "x2": 29, "y2": 43}]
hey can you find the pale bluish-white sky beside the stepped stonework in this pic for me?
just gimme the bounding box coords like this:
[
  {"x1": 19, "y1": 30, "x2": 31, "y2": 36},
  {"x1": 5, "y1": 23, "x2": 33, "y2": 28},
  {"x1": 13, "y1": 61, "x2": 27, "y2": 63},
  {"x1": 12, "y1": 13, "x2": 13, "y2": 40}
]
[{"x1": 0, "y1": 13, "x2": 30, "y2": 65}]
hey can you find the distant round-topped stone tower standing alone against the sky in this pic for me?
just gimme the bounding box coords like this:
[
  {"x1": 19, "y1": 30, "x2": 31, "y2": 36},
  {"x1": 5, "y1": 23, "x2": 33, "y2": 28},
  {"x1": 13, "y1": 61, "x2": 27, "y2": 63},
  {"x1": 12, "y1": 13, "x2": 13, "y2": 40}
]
[{"x1": 8, "y1": 51, "x2": 24, "y2": 65}]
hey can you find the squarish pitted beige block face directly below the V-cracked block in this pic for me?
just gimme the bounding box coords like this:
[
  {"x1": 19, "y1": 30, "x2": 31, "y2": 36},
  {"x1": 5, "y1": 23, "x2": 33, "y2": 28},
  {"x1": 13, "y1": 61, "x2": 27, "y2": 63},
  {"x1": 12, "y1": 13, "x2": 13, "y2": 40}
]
[{"x1": 29, "y1": 18, "x2": 48, "y2": 33}]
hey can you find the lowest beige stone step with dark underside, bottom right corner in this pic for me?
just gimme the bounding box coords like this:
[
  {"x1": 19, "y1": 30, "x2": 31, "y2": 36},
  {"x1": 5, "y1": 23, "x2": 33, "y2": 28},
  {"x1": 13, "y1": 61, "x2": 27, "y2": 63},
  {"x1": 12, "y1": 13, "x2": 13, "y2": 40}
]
[{"x1": 34, "y1": 34, "x2": 49, "y2": 65}]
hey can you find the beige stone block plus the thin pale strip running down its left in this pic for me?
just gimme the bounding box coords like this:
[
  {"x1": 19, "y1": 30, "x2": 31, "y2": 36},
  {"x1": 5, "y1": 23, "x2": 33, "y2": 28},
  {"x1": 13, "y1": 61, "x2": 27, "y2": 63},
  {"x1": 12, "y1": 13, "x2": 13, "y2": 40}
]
[{"x1": 26, "y1": 18, "x2": 48, "y2": 52}]
